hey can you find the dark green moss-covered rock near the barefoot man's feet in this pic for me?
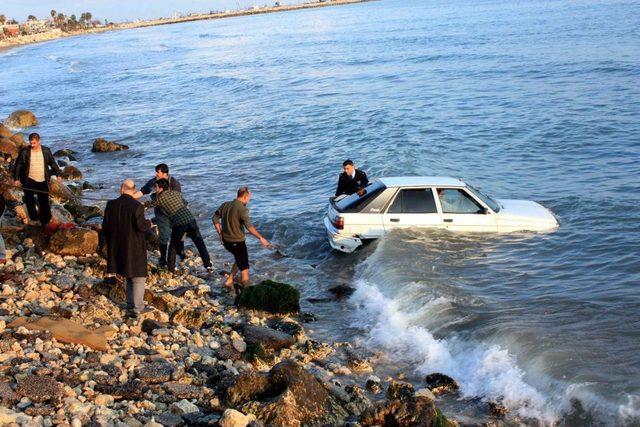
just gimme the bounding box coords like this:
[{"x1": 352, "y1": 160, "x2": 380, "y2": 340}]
[{"x1": 236, "y1": 280, "x2": 300, "y2": 314}]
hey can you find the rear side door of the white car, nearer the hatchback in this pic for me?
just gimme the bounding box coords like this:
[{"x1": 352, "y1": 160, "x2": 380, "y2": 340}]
[{"x1": 383, "y1": 187, "x2": 443, "y2": 231}]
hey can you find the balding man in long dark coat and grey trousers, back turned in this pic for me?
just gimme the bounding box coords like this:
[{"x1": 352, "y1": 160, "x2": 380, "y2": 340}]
[{"x1": 102, "y1": 179, "x2": 151, "y2": 318}]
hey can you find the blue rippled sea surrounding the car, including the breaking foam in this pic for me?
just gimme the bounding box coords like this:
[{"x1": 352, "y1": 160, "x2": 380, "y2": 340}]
[{"x1": 0, "y1": 0, "x2": 640, "y2": 425}]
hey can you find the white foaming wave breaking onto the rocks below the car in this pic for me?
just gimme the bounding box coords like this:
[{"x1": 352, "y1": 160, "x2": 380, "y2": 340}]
[{"x1": 350, "y1": 236, "x2": 640, "y2": 425}]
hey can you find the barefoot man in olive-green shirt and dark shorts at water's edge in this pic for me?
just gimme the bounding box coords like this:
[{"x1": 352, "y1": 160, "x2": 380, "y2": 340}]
[{"x1": 213, "y1": 187, "x2": 269, "y2": 289}]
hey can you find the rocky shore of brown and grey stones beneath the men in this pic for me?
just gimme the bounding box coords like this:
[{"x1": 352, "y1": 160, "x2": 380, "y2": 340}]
[{"x1": 0, "y1": 112, "x2": 457, "y2": 427}]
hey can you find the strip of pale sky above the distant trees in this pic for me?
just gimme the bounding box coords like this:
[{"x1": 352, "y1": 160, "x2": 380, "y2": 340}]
[{"x1": 0, "y1": 0, "x2": 301, "y2": 22}]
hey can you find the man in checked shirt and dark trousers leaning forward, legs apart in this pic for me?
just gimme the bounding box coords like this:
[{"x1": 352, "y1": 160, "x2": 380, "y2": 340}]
[{"x1": 146, "y1": 178, "x2": 213, "y2": 273}]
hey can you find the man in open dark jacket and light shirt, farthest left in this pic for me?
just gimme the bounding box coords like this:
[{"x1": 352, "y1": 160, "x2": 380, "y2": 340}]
[{"x1": 13, "y1": 133, "x2": 62, "y2": 226}]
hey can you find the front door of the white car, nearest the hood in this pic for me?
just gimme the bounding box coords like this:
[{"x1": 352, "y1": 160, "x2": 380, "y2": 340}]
[{"x1": 436, "y1": 188, "x2": 498, "y2": 232}]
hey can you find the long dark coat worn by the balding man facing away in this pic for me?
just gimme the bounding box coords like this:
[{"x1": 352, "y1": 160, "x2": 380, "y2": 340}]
[{"x1": 102, "y1": 194, "x2": 151, "y2": 277}]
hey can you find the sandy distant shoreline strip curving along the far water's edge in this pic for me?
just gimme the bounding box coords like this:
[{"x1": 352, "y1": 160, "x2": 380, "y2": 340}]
[{"x1": 0, "y1": 0, "x2": 374, "y2": 51}]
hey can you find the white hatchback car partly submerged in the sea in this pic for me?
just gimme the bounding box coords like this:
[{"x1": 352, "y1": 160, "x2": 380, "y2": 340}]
[{"x1": 324, "y1": 176, "x2": 558, "y2": 253}]
